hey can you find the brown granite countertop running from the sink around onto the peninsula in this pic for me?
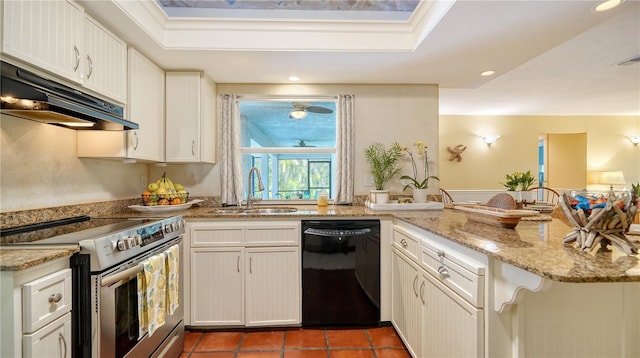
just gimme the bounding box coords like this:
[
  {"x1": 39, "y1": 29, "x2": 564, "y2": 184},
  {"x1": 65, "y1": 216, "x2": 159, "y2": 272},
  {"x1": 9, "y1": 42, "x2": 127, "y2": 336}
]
[{"x1": 5, "y1": 201, "x2": 640, "y2": 282}]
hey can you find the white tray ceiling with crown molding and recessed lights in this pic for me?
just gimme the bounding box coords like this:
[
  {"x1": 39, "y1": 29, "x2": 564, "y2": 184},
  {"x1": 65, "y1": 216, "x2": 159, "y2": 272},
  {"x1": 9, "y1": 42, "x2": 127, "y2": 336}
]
[{"x1": 80, "y1": 0, "x2": 640, "y2": 115}]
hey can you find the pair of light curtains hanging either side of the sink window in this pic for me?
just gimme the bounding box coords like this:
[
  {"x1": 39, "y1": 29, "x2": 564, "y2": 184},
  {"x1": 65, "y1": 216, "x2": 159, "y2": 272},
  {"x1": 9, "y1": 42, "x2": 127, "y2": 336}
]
[{"x1": 219, "y1": 94, "x2": 355, "y2": 204}]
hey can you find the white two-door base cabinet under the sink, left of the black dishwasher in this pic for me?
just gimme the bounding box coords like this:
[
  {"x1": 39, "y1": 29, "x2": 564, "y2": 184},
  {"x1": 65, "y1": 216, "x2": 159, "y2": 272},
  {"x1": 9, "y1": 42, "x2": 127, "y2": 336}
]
[{"x1": 185, "y1": 220, "x2": 301, "y2": 326}]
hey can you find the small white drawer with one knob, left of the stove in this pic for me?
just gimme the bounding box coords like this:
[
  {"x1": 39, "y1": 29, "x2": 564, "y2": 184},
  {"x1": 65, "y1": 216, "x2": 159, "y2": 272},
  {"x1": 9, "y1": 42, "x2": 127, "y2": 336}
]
[{"x1": 22, "y1": 269, "x2": 71, "y2": 333}]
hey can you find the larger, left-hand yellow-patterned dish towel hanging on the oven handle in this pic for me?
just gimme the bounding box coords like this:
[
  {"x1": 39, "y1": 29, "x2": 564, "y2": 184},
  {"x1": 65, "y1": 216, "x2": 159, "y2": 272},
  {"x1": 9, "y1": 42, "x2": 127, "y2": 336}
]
[{"x1": 138, "y1": 253, "x2": 167, "y2": 337}]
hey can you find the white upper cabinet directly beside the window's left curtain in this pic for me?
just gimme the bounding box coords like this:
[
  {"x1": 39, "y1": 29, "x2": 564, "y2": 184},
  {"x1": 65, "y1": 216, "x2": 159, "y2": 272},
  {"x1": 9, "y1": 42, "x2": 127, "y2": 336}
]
[{"x1": 166, "y1": 72, "x2": 216, "y2": 163}]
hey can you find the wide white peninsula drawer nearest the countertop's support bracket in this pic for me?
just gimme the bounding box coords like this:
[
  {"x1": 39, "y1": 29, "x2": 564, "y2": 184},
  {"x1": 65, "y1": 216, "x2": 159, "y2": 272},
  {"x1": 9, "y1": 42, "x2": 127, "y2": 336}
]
[{"x1": 420, "y1": 240, "x2": 484, "y2": 307}]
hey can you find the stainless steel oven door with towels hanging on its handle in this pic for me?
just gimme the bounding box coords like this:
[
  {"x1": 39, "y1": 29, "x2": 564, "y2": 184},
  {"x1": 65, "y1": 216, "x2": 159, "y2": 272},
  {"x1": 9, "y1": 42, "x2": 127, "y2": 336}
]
[{"x1": 93, "y1": 238, "x2": 184, "y2": 358}]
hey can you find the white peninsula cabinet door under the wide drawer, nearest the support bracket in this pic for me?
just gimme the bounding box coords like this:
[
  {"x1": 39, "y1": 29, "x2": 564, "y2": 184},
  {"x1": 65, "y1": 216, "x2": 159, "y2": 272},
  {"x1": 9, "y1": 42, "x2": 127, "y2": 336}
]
[{"x1": 420, "y1": 274, "x2": 484, "y2": 357}]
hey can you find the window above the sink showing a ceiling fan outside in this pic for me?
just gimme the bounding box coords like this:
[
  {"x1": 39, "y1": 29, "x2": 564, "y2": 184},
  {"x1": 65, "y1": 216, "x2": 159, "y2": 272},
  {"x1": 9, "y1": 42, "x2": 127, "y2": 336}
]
[{"x1": 238, "y1": 97, "x2": 336, "y2": 200}]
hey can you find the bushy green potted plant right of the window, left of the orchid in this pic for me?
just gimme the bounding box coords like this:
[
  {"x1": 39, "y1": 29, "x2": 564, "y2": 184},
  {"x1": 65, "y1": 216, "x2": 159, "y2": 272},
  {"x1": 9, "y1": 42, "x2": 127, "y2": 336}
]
[{"x1": 364, "y1": 143, "x2": 402, "y2": 190}]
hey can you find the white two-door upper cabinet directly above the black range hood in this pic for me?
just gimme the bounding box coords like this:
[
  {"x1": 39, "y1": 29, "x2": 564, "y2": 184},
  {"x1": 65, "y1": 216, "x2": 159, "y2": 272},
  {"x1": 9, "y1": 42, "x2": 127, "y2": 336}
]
[{"x1": 2, "y1": 0, "x2": 127, "y2": 103}]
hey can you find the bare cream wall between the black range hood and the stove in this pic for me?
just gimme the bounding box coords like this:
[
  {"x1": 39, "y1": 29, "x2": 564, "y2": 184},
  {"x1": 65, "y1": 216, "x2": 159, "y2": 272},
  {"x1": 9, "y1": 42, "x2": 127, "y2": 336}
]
[{"x1": 0, "y1": 115, "x2": 147, "y2": 212}]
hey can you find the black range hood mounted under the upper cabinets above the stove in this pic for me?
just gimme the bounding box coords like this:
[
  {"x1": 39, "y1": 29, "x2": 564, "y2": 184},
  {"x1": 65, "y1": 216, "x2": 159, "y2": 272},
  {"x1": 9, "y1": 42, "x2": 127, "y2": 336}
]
[{"x1": 0, "y1": 61, "x2": 139, "y2": 131}]
